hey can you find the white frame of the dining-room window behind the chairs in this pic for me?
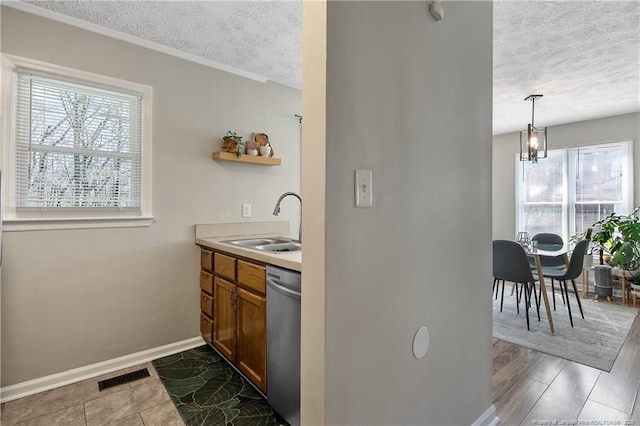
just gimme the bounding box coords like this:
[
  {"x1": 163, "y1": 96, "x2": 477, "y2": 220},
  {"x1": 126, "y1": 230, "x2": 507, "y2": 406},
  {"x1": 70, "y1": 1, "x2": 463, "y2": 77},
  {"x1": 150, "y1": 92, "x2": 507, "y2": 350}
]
[{"x1": 514, "y1": 139, "x2": 635, "y2": 243}]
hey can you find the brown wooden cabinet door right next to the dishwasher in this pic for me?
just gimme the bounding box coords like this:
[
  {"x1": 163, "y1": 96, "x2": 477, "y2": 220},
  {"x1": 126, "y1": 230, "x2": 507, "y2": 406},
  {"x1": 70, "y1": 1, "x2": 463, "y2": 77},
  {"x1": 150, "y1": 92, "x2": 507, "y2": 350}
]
[{"x1": 236, "y1": 288, "x2": 267, "y2": 393}]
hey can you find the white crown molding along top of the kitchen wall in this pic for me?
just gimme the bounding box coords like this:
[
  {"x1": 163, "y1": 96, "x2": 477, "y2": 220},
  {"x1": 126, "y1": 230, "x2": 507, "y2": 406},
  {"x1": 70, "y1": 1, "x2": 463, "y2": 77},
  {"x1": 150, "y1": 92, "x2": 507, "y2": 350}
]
[{"x1": 0, "y1": 0, "x2": 269, "y2": 83}]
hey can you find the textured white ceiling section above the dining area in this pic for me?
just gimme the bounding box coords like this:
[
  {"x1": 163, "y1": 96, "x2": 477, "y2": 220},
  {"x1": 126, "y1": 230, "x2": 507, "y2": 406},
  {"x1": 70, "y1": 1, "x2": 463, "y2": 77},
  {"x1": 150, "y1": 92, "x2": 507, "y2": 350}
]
[{"x1": 496, "y1": 0, "x2": 640, "y2": 134}]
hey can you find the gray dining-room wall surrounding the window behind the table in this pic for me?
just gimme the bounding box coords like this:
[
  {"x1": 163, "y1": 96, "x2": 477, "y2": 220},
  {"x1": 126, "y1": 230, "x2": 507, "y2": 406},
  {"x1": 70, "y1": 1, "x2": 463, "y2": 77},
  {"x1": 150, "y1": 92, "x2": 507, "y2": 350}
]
[{"x1": 493, "y1": 113, "x2": 640, "y2": 240}]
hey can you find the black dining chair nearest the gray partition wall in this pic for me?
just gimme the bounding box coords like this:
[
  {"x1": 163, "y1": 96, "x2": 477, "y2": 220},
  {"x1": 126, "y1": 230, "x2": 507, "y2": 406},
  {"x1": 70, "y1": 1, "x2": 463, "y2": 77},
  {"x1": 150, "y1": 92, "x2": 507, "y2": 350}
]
[{"x1": 493, "y1": 240, "x2": 540, "y2": 330}]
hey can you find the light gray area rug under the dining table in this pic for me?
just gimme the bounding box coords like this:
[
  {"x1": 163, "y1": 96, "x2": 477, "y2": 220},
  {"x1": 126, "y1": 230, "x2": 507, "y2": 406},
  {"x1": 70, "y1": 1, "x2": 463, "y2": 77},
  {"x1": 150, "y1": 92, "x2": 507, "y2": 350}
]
[{"x1": 493, "y1": 287, "x2": 638, "y2": 372}]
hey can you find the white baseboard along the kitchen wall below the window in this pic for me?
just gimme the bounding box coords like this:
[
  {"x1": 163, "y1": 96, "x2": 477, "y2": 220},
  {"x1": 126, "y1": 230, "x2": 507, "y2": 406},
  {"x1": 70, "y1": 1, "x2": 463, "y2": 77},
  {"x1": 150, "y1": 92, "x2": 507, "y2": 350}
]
[{"x1": 0, "y1": 336, "x2": 205, "y2": 403}]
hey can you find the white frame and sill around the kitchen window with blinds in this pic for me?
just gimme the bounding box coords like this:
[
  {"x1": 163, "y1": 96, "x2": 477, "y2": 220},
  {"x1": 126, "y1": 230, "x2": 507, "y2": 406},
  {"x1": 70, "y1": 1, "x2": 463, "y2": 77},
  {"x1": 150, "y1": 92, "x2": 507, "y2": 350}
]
[{"x1": 0, "y1": 54, "x2": 155, "y2": 231}]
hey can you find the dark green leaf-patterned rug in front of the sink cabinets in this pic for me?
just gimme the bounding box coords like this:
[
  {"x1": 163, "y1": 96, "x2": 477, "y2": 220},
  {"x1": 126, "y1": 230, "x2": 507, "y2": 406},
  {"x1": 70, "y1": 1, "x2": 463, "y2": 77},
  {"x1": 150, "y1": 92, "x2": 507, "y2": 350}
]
[{"x1": 153, "y1": 345, "x2": 286, "y2": 426}]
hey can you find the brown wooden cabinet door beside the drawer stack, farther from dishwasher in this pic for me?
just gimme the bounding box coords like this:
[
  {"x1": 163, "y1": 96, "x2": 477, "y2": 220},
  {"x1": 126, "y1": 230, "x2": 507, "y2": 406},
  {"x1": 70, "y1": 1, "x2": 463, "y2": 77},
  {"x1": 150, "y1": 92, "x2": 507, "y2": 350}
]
[{"x1": 213, "y1": 277, "x2": 236, "y2": 362}]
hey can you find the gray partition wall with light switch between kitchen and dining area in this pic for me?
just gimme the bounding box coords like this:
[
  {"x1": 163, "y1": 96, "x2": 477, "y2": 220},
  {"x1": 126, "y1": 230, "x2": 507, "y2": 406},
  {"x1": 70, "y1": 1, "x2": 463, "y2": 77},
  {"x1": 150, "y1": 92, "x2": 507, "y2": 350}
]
[{"x1": 325, "y1": 2, "x2": 492, "y2": 425}]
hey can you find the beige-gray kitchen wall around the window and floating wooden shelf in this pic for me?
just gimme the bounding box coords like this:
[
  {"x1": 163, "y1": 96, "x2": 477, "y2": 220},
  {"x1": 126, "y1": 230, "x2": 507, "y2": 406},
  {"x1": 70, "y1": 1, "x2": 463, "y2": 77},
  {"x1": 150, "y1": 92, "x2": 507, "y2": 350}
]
[{"x1": 1, "y1": 7, "x2": 302, "y2": 386}]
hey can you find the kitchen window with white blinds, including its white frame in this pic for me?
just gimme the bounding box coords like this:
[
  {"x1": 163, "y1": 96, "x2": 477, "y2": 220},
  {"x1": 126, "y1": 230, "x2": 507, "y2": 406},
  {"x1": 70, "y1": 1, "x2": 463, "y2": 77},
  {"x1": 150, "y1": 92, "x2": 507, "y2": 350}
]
[{"x1": 3, "y1": 56, "x2": 151, "y2": 231}]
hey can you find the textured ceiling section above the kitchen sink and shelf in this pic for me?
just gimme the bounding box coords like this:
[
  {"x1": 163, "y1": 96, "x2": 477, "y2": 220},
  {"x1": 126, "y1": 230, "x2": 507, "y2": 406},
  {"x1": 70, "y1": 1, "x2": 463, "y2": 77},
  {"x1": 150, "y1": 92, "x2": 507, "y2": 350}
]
[{"x1": 23, "y1": 0, "x2": 302, "y2": 88}]
